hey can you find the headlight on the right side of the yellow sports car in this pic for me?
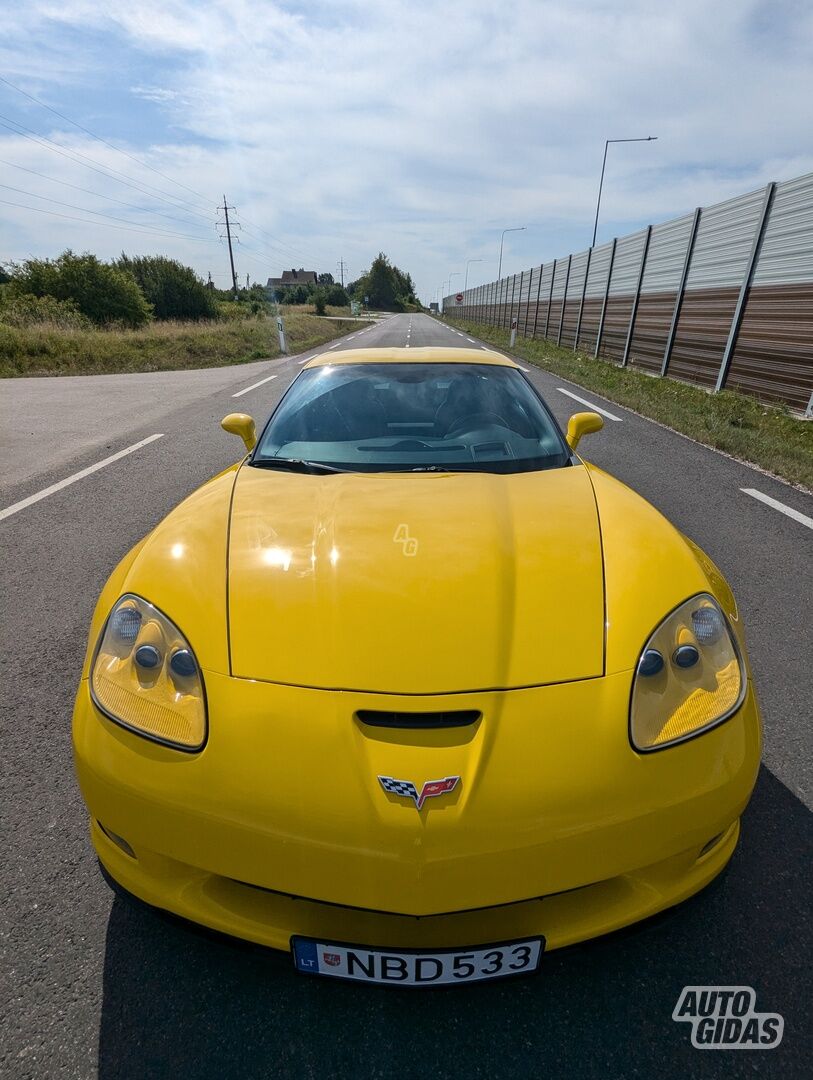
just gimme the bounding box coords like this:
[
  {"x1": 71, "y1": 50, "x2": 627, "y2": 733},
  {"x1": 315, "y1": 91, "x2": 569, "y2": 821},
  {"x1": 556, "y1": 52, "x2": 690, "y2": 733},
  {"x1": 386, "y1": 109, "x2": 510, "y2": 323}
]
[{"x1": 629, "y1": 593, "x2": 745, "y2": 751}]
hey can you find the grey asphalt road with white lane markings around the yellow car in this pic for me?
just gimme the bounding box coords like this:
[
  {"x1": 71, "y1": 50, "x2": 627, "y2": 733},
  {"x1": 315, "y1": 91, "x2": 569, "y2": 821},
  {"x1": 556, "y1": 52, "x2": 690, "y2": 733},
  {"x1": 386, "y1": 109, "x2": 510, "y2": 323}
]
[{"x1": 0, "y1": 315, "x2": 813, "y2": 1080}]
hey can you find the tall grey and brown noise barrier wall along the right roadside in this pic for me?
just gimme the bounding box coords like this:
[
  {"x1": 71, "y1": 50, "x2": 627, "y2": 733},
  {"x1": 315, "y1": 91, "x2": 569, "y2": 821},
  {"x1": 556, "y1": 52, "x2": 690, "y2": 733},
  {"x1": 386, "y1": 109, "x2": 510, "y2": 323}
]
[{"x1": 444, "y1": 173, "x2": 813, "y2": 416}]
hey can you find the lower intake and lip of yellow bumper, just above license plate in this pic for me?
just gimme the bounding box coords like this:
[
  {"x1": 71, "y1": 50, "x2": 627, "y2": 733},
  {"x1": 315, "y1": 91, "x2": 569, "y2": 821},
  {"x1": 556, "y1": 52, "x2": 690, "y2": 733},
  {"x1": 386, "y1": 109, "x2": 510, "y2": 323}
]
[{"x1": 91, "y1": 821, "x2": 740, "y2": 951}]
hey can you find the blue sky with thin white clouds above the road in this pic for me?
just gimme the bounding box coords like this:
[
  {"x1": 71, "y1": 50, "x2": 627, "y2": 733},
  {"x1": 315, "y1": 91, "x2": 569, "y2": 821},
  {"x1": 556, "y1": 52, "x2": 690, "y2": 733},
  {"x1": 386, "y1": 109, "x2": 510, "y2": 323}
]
[{"x1": 0, "y1": 0, "x2": 813, "y2": 302}]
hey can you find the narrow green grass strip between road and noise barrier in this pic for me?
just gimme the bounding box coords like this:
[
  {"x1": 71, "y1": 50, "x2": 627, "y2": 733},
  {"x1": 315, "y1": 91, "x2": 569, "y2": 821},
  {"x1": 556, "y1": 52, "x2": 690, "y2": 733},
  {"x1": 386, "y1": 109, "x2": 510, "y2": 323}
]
[{"x1": 444, "y1": 320, "x2": 813, "y2": 491}]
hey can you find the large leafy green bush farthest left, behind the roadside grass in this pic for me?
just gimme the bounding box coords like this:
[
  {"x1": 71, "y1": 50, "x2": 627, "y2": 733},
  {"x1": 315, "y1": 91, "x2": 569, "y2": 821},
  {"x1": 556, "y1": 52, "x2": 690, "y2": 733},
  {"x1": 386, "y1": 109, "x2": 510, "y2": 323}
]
[{"x1": 6, "y1": 251, "x2": 151, "y2": 327}]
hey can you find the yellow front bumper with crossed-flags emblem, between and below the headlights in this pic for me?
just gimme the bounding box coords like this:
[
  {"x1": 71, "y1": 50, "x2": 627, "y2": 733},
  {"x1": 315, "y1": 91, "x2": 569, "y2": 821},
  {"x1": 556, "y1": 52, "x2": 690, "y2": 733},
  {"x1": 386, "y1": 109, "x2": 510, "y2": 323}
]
[{"x1": 73, "y1": 672, "x2": 760, "y2": 948}]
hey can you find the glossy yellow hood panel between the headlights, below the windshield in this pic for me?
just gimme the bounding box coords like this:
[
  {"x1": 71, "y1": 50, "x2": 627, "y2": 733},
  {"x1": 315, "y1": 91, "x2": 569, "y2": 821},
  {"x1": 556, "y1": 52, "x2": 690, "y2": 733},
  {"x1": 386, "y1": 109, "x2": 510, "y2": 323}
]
[{"x1": 228, "y1": 465, "x2": 605, "y2": 693}]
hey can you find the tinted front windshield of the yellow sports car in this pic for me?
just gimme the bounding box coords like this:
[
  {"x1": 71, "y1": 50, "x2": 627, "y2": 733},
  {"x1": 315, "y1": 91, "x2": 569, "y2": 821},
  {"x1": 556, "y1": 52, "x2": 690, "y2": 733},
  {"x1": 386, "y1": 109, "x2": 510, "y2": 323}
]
[{"x1": 252, "y1": 363, "x2": 570, "y2": 473}]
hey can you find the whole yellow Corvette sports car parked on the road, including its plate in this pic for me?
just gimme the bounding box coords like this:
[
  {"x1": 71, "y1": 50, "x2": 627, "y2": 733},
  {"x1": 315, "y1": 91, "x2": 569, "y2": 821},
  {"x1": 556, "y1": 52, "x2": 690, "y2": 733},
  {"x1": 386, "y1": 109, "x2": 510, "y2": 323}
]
[{"x1": 73, "y1": 349, "x2": 760, "y2": 987}]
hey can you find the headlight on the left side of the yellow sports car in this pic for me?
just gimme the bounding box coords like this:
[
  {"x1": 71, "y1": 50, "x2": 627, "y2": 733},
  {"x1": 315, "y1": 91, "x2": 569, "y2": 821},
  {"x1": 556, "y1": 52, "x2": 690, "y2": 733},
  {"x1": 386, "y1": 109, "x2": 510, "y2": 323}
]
[{"x1": 91, "y1": 594, "x2": 206, "y2": 750}]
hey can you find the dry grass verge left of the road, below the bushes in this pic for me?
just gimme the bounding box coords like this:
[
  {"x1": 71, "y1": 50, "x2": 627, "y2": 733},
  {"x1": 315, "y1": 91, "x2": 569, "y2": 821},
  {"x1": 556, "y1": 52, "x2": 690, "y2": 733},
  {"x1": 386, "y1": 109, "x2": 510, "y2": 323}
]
[{"x1": 0, "y1": 312, "x2": 357, "y2": 378}]
